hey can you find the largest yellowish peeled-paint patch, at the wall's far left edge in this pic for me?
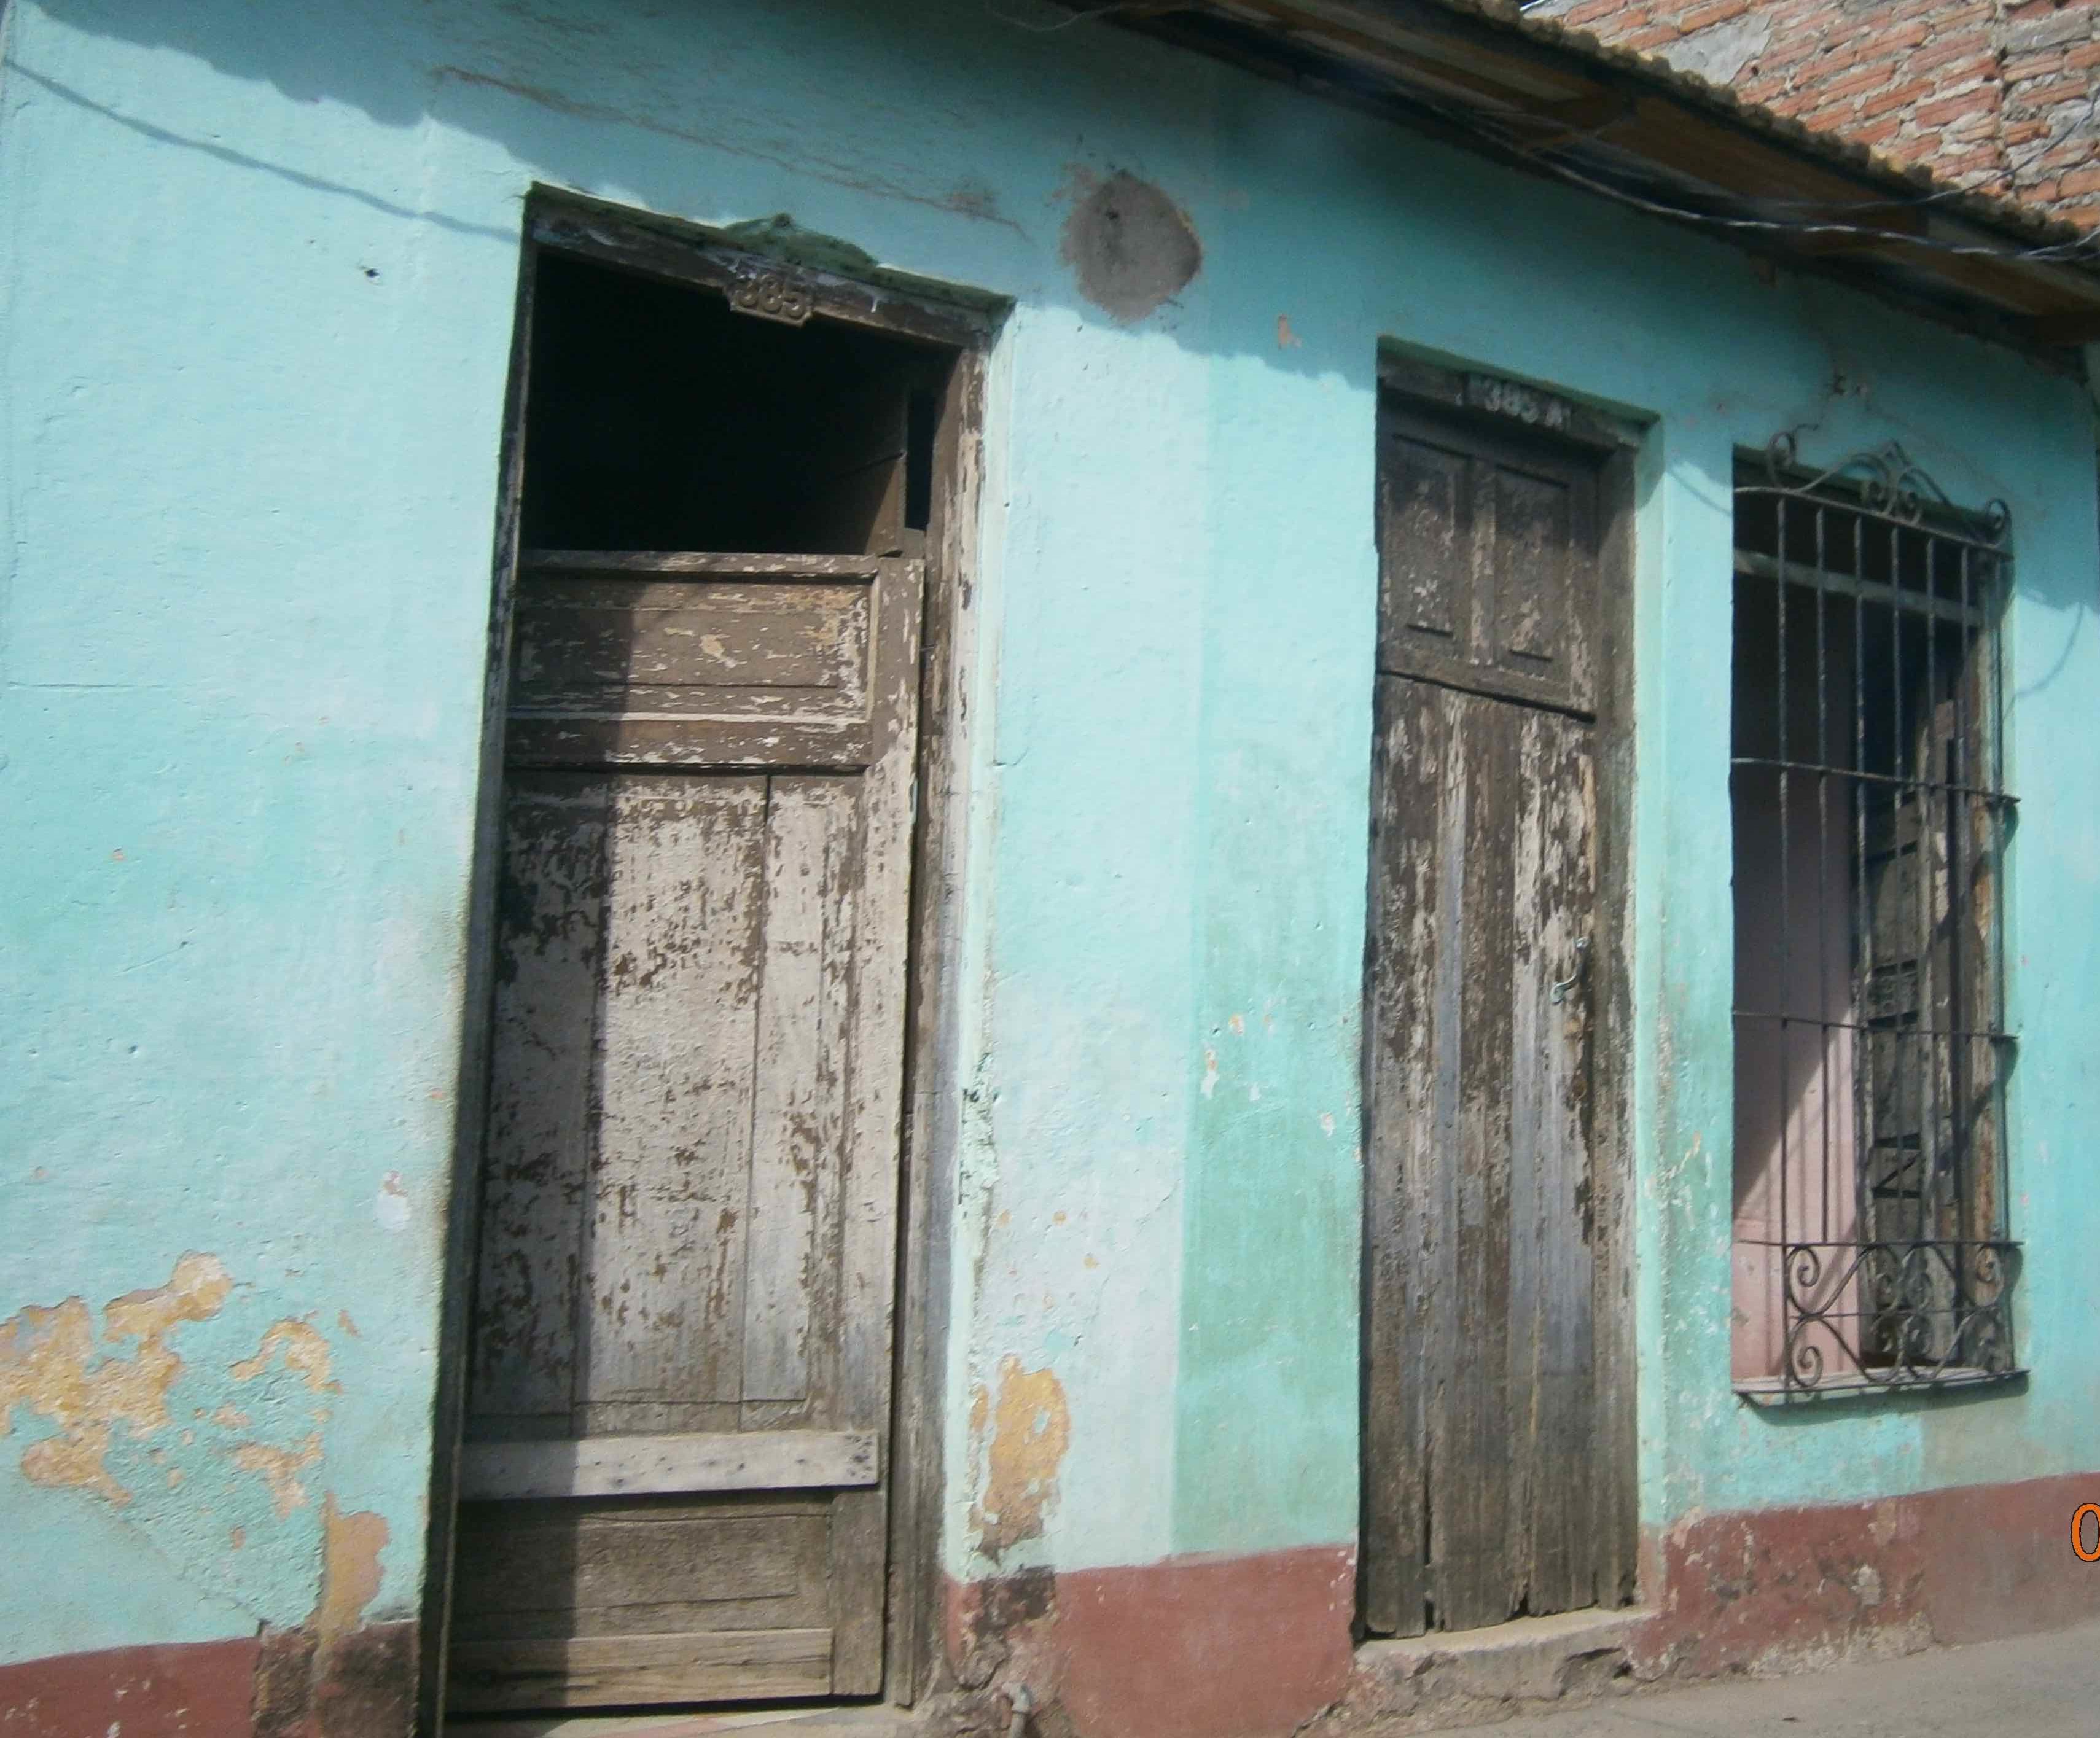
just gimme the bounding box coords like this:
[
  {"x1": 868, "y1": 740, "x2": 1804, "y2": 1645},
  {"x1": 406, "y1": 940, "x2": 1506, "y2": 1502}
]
[{"x1": 0, "y1": 1253, "x2": 233, "y2": 1507}]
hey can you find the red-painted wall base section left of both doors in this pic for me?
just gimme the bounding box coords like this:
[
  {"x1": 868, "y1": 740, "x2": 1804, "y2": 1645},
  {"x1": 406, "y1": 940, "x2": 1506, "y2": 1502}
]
[{"x1": 0, "y1": 1623, "x2": 416, "y2": 1738}]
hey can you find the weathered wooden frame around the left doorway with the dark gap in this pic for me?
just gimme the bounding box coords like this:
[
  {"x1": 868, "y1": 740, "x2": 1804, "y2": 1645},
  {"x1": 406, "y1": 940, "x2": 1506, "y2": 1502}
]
[{"x1": 416, "y1": 187, "x2": 1006, "y2": 1738}]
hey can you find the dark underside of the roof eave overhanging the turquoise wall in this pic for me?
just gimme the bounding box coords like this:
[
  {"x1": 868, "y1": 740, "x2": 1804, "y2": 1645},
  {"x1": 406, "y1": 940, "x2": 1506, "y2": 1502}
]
[{"x1": 1079, "y1": 0, "x2": 2100, "y2": 361}]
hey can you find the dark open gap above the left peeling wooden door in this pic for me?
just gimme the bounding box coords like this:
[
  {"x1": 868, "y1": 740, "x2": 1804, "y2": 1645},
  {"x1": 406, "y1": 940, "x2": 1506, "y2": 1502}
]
[{"x1": 523, "y1": 252, "x2": 949, "y2": 554}]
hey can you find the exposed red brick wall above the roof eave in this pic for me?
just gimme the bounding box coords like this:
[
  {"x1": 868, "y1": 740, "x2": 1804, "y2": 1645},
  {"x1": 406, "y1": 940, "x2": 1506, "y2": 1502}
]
[{"x1": 1529, "y1": 0, "x2": 2100, "y2": 227}]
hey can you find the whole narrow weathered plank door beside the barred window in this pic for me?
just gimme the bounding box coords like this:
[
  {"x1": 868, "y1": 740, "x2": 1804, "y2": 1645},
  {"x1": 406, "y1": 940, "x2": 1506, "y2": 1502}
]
[{"x1": 1363, "y1": 399, "x2": 1630, "y2": 1635}]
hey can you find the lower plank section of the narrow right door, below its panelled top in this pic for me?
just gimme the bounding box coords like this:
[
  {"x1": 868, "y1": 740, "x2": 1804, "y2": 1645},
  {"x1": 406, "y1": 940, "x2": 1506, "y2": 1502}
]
[{"x1": 1365, "y1": 676, "x2": 1596, "y2": 1633}]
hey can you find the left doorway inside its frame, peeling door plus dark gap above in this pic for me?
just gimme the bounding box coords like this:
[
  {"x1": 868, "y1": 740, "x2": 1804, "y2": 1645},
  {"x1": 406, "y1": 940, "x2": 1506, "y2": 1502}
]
[{"x1": 445, "y1": 214, "x2": 959, "y2": 1715}]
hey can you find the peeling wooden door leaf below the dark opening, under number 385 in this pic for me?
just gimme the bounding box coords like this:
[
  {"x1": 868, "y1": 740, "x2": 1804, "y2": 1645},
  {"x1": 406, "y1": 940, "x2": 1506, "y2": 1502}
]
[{"x1": 450, "y1": 554, "x2": 922, "y2": 1709}]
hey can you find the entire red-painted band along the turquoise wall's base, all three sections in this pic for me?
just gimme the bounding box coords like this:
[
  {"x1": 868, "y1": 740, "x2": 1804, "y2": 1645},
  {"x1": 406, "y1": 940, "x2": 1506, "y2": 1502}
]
[{"x1": 20, "y1": 1473, "x2": 2100, "y2": 1738}]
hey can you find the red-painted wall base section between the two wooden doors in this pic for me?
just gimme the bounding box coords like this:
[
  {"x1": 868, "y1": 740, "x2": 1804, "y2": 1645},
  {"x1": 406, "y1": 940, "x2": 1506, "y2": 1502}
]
[{"x1": 947, "y1": 1545, "x2": 1357, "y2": 1738}]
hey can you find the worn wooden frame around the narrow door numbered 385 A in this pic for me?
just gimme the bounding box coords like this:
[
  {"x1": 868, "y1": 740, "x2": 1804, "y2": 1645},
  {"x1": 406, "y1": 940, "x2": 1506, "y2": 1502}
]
[{"x1": 1357, "y1": 348, "x2": 1646, "y2": 1637}]
